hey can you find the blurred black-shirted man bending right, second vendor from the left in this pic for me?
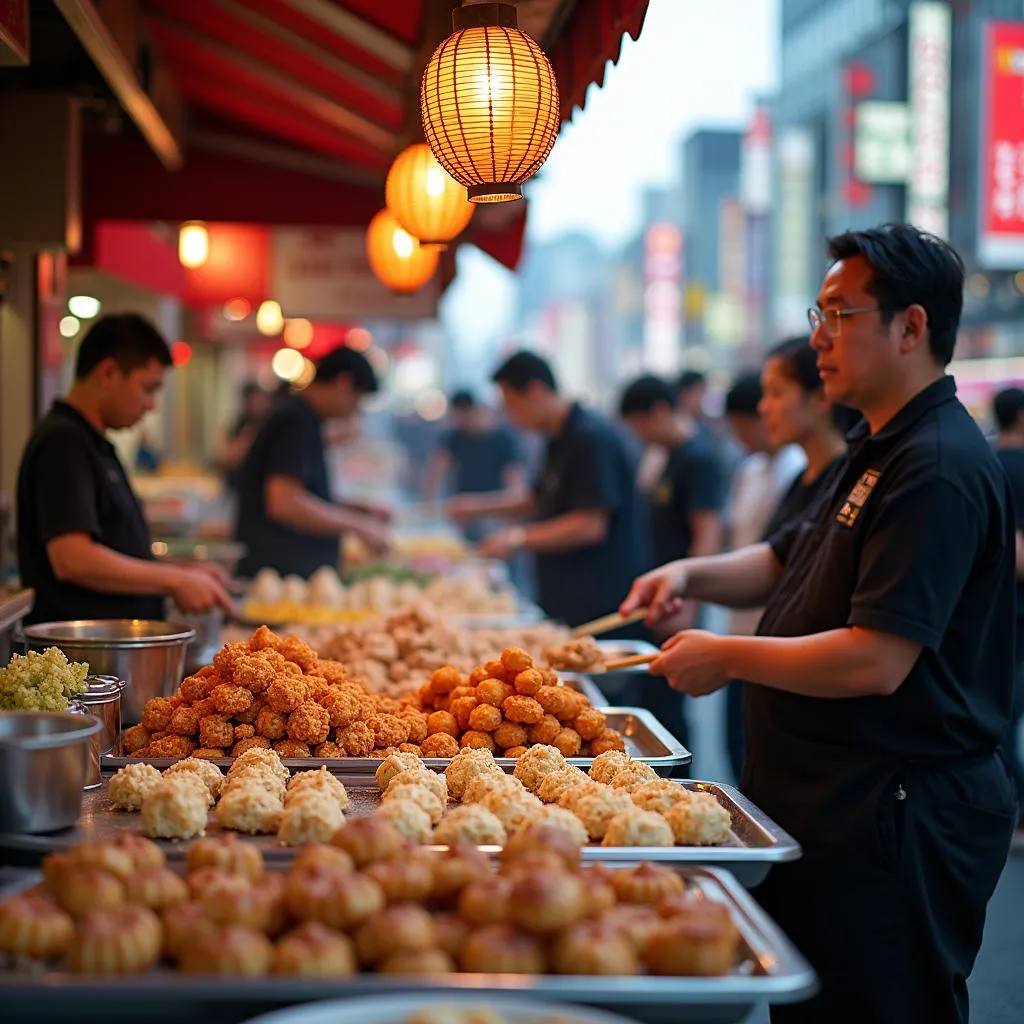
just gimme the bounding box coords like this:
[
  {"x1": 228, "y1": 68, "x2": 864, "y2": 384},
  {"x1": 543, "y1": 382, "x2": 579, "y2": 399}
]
[{"x1": 236, "y1": 346, "x2": 390, "y2": 578}]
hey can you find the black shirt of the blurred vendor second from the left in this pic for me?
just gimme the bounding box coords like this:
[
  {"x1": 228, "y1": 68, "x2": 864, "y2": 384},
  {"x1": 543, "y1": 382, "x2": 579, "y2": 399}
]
[{"x1": 236, "y1": 395, "x2": 341, "y2": 578}]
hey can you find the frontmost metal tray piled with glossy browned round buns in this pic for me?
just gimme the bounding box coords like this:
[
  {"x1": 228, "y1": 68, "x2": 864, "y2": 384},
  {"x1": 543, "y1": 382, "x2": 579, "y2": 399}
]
[{"x1": 0, "y1": 817, "x2": 814, "y2": 1020}]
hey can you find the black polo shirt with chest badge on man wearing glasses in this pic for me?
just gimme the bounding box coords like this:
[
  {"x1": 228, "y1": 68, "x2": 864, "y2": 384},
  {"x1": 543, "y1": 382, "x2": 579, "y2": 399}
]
[{"x1": 743, "y1": 377, "x2": 1015, "y2": 842}]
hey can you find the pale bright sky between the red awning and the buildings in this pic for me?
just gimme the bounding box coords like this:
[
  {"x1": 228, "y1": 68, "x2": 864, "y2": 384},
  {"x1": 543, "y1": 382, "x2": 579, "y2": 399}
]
[{"x1": 442, "y1": 0, "x2": 779, "y2": 361}]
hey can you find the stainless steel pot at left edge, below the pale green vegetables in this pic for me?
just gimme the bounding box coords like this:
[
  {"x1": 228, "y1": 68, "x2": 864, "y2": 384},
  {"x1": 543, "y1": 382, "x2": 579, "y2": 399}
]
[{"x1": 0, "y1": 712, "x2": 102, "y2": 834}]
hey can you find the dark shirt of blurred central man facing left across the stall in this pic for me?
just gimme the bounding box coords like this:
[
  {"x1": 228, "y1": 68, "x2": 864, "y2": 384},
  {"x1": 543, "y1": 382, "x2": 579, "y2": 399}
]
[{"x1": 535, "y1": 404, "x2": 649, "y2": 626}]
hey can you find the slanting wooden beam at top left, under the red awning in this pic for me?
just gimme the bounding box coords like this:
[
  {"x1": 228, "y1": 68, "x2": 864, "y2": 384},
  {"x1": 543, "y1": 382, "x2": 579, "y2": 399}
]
[{"x1": 53, "y1": 0, "x2": 183, "y2": 171}]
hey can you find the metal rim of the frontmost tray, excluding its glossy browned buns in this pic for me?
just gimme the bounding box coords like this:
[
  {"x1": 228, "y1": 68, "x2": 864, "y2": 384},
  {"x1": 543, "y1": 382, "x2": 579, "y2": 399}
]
[{"x1": 0, "y1": 860, "x2": 817, "y2": 1024}]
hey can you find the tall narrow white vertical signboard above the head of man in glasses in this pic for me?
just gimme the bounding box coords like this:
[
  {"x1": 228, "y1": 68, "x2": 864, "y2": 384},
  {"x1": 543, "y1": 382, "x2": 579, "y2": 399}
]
[{"x1": 906, "y1": 3, "x2": 952, "y2": 239}]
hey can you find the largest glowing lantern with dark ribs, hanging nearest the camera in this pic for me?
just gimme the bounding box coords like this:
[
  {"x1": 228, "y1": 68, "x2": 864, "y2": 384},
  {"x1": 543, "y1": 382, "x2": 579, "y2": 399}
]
[{"x1": 420, "y1": 3, "x2": 559, "y2": 203}]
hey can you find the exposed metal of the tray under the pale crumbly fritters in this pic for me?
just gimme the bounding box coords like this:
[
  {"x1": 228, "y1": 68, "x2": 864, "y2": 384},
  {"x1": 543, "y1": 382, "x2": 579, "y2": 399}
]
[{"x1": 0, "y1": 775, "x2": 801, "y2": 887}]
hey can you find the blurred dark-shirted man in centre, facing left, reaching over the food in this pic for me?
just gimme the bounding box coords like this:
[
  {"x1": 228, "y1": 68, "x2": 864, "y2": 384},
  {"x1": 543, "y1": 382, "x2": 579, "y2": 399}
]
[{"x1": 452, "y1": 352, "x2": 647, "y2": 626}]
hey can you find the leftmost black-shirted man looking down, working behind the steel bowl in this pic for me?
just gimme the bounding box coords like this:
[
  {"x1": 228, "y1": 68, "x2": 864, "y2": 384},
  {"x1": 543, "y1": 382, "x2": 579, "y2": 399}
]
[{"x1": 17, "y1": 313, "x2": 231, "y2": 623}]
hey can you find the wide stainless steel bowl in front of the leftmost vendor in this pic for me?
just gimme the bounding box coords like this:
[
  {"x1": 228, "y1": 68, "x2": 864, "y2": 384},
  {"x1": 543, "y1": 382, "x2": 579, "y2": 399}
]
[{"x1": 24, "y1": 618, "x2": 196, "y2": 725}]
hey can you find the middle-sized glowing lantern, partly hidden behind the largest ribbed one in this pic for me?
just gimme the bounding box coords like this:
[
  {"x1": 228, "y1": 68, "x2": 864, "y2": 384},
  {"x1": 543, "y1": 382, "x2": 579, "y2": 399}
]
[{"x1": 384, "y1": 142, "x2": 473, "y2": 246}]
